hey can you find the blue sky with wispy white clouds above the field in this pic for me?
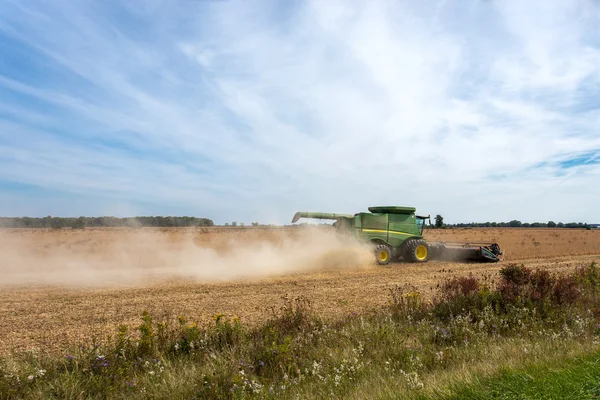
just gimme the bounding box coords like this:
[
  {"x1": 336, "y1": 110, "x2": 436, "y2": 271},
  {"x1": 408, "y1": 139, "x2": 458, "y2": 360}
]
[{"x1": 0, "y1": 0, "x2": 600, "y2": 223}]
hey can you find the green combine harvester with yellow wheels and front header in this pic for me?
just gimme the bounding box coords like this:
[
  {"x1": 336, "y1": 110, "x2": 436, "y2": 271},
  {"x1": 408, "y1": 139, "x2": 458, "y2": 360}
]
[{"x1": 292, "y1": 206, "x2": 502, "y2": 265}]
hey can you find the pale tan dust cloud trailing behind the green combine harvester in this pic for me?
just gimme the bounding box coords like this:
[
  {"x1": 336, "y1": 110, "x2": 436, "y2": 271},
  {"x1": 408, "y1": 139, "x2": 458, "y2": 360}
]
[{"x1": 0, "y1": 227, "x2": 372, "y2": 287}]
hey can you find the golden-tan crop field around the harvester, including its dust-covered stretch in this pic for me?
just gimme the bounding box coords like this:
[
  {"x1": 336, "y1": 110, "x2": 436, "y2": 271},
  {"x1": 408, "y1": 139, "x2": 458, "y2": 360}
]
[{"x1": 0, "y1": 228, "x2": 600, "y2": 352}]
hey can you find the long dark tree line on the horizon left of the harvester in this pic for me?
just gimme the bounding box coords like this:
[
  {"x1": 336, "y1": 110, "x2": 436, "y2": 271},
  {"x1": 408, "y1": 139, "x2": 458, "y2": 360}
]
[{"x1": 0, "y1": 216, "x2": 214, "y2": 229}]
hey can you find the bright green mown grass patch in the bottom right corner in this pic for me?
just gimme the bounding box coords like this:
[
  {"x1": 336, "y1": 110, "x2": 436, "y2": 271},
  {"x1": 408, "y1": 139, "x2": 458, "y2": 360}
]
[{"x1": 434, "y1": 352, "x2": 600, "y2": 400}]
